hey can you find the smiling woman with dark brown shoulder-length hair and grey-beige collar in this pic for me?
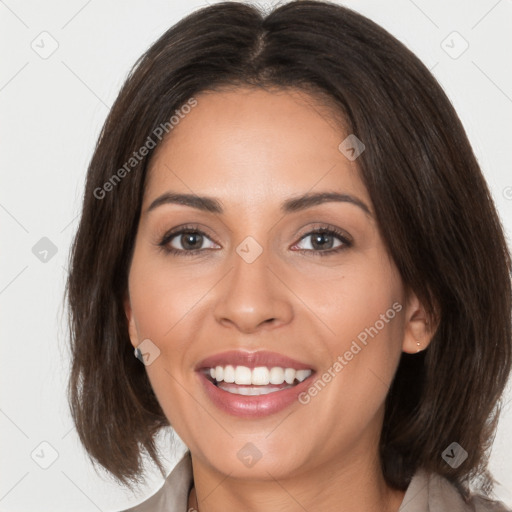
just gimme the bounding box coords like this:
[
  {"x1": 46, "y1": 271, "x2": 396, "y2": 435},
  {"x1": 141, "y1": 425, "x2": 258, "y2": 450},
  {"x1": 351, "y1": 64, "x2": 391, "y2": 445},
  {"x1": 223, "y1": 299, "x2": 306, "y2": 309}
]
[{"x1": 67, "y1": 1, "x2": 512, "y2": 512}]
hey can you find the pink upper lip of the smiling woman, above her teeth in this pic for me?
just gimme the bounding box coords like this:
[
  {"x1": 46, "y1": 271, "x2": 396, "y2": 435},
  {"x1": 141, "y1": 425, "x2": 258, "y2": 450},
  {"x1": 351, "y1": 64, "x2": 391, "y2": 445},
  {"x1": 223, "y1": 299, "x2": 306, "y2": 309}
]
[{"x1": 195, "y1": 350, "x2": 313, "y2": 370}]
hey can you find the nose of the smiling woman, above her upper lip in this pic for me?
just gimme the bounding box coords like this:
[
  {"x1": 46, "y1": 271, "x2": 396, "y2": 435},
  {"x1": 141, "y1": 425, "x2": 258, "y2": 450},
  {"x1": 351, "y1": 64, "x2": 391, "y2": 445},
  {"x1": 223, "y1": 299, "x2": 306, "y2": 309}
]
[{"x1": 214, "y1": 243, "x2": 293, "y2": 333}]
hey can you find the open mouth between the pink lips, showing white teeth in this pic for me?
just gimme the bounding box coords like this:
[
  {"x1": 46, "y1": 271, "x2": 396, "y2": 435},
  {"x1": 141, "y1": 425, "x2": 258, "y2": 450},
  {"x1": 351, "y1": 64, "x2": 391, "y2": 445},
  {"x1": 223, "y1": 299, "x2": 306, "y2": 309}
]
[{"x1": 201, "y1": 365, "x2": 313, "y2": 396}]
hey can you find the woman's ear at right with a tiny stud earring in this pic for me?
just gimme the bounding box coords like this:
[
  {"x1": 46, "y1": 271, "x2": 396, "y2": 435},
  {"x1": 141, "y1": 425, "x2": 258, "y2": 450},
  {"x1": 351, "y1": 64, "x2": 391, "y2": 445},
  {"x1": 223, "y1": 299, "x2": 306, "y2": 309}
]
[{"x1": 402, "y1": 292, "x2": 437, "y2": 354}]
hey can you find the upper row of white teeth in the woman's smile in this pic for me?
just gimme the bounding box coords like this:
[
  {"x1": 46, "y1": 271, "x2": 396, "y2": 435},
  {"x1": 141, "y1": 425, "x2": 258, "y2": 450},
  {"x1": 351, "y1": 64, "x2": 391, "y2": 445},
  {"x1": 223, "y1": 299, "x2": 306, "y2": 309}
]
[{"x1": 210, "y1": 365, "x2": 311, "y2": 389}]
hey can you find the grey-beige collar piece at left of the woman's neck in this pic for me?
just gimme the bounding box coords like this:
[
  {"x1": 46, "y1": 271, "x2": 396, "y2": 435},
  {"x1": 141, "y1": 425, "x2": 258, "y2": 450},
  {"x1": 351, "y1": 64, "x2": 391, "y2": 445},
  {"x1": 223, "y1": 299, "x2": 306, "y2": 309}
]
[{"x1": 121, "y1": 451, "x2": 193, "y2": 512}]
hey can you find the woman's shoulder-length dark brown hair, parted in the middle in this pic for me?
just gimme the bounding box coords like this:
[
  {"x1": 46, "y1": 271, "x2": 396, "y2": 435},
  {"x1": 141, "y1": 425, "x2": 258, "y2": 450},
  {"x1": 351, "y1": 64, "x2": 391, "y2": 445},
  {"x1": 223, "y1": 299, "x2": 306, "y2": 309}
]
[{"x1": 66, "y1": 1, "x2": 512, "y2": 498}]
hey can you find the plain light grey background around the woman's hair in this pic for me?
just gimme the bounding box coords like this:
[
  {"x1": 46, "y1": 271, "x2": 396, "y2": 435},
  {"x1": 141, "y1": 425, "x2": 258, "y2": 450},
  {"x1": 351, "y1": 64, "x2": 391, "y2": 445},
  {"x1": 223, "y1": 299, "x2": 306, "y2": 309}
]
[{"x1": 0, "y1": 0, "x2": 512, "y2": 512}]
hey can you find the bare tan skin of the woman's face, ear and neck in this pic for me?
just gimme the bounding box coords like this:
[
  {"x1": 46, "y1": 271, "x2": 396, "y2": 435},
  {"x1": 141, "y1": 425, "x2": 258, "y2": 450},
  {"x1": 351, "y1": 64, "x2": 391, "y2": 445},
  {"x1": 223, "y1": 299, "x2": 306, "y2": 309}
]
[{"x1": 125, "y1": 88, "x2": 431, "y2": 512}]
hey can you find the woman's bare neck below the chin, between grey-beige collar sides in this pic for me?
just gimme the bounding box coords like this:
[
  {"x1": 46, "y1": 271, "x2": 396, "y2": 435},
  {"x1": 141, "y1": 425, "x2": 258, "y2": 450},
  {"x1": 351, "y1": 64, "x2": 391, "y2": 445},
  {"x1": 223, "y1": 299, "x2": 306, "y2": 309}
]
[{"x1": 188, "y1": 448, "x2": 405, "y2": 512}]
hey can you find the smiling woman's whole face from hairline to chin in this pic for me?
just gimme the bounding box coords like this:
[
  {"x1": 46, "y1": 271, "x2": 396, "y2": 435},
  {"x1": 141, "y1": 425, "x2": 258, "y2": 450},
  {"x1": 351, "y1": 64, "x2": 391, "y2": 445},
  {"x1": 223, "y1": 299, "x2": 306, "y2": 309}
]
[{"x1": 125, "y1": 88, "x2": 424, "y2": 479}]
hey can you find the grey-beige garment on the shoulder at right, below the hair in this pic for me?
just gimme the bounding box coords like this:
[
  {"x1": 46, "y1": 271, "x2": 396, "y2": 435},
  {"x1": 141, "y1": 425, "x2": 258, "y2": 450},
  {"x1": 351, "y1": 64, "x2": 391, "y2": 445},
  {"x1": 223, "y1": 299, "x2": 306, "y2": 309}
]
[{"x1": 400, "y1": 469, "x2": 512, "y2": 512}]
